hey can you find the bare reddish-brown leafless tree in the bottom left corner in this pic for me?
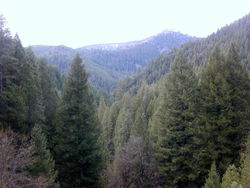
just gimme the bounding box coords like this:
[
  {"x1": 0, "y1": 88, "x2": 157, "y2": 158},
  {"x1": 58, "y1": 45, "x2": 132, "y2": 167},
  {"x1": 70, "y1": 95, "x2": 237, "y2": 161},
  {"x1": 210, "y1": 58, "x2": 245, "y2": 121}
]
[{"x1": 0, "y1": 129, "x2": 49, "y2": 188}]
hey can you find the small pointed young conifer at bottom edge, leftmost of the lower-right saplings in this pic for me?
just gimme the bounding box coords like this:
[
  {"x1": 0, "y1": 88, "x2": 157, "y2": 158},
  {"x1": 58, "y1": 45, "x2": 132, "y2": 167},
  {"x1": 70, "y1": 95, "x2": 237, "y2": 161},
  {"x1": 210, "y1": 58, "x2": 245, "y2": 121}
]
[{"x1": 203, "y1": 162, "x2": 220, "y2": 188}]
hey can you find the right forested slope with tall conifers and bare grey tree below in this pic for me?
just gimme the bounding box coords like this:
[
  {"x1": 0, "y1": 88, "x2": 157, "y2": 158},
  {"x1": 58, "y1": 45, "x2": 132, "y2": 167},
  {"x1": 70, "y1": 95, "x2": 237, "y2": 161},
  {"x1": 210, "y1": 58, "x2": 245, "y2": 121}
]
[{"x1": 98, "y1": 12, "x2": 250, "y2": 188}]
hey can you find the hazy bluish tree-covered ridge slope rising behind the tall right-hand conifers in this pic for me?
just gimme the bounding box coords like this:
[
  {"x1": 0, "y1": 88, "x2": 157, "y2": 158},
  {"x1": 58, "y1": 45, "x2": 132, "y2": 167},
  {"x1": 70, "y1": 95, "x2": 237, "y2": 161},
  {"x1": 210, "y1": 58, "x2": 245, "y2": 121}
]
[{"x1": 119, "y1": 14, "x2": 250, "y2": 94}]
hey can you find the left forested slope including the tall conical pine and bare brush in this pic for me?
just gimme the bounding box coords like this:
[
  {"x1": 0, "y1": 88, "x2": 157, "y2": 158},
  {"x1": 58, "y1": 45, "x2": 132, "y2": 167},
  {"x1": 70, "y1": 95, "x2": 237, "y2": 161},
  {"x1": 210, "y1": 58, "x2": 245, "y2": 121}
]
[{"x1": 0, "y1": 16, "x2": 103, "y2": 188}]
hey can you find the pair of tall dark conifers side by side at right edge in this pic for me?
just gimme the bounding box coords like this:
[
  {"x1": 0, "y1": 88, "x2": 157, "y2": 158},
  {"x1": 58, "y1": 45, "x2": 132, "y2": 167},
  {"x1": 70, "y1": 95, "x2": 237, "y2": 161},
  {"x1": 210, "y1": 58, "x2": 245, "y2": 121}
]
[{"x1": 200, "y1": 45, "x2": 250, "y2": 175}]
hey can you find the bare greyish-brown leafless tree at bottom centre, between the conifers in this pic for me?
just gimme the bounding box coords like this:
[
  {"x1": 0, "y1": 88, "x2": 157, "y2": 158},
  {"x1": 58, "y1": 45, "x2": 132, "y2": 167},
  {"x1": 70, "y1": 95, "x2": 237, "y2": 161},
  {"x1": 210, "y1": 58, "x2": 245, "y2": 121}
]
[{"x1": 106, "y1": 137, "x2": 159, "y2": 188}]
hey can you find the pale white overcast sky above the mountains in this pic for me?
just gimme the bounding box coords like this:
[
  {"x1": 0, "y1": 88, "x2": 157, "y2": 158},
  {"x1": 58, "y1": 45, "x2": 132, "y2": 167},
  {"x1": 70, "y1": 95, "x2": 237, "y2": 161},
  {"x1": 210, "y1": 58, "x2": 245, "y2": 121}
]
[{"x1": 0, "y1": 0, "x2": 250, "y2": 48}]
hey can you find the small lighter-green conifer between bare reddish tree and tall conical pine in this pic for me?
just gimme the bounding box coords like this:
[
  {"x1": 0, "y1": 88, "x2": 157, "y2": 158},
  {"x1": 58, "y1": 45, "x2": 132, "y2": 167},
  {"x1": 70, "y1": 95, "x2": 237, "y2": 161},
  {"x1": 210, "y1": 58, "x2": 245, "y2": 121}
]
[{"x1": 30, "y1": 125, "x2": 58, "y2": 187}]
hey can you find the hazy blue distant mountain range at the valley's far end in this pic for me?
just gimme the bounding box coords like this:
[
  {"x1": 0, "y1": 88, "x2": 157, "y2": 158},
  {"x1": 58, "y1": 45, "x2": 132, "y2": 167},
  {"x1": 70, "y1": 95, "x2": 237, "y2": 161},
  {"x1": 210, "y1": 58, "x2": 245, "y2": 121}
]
[{"x1": 32, "y1": 31, "x2": 196, "y2": 91}]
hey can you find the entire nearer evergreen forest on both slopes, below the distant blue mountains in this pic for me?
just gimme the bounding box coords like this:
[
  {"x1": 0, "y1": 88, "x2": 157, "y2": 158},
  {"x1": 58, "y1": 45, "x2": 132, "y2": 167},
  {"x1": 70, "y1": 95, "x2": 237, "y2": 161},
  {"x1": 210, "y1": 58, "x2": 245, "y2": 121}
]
[{"x1": 0, "y1": 14, "x2": 250, "y2": 188}]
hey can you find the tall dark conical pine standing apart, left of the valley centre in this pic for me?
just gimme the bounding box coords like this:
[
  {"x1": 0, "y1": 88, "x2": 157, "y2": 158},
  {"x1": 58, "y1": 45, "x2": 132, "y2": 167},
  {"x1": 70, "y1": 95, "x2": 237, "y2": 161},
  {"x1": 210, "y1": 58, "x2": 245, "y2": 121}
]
[{"x1": 53, "y1": 55, "x2": 102, "y2": 187}]
